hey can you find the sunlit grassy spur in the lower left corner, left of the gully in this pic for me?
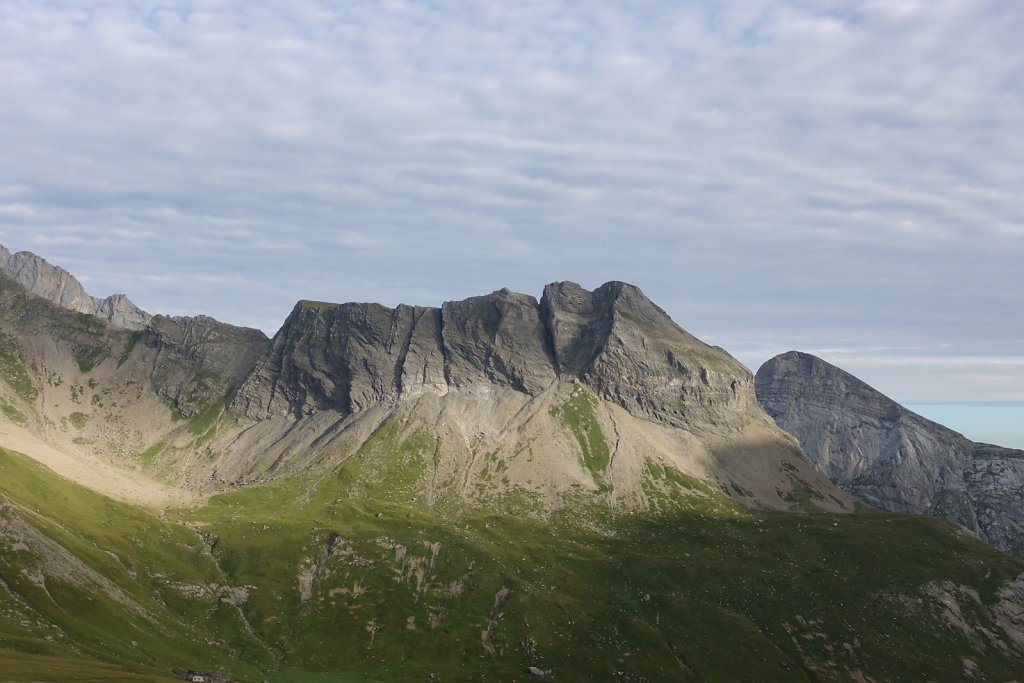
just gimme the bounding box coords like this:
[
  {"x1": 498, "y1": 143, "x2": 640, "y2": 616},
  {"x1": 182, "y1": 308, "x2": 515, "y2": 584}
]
[{"x1": 0, "y1": 449, "x2": 266, "y2": 680}]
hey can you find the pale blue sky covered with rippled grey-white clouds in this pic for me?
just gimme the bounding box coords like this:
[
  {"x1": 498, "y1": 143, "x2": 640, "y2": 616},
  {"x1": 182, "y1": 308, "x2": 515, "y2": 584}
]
[{"x1": 0, "y1": 0, "x2": 1024, "y2": 447}]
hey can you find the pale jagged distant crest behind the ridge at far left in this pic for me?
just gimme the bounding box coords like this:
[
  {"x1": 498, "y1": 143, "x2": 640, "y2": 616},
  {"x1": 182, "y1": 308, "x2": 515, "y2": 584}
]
[{"x1": 0, "y1": 247, "x2": 153, "y2": 330}]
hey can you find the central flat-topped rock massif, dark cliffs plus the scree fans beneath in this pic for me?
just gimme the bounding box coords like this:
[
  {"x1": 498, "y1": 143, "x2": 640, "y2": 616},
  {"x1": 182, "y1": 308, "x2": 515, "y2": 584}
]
[{"x1": 222, "y1": 282, "x2": 839, "y2": 510}]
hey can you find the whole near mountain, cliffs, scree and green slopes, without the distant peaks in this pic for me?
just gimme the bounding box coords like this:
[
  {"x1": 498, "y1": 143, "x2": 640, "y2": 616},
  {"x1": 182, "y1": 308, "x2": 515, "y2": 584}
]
[{"x1": 0, "y1": 248, "x2": 1024, "y2": 682}]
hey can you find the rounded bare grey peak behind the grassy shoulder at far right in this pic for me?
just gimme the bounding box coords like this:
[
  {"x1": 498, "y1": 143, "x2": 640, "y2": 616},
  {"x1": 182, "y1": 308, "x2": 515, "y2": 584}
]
[{"x1": 756, "y1": 351, "x2": 1024, "y2": 554}]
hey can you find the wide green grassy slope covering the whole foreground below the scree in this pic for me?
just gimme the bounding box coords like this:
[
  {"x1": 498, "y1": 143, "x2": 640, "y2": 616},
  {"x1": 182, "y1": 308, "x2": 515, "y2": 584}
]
[{"x1": 0, "y1": 413, "x2": 1024, "y2": 681}]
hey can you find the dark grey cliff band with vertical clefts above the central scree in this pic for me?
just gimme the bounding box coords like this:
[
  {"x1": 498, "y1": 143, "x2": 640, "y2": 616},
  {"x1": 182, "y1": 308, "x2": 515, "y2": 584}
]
[{"x1": 232, "y1": 282, "x2": 756, "y2": 429}]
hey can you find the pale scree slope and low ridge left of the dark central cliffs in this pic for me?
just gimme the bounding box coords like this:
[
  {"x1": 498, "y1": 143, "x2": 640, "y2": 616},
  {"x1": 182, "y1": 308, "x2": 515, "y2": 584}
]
[{"x1": 0, "y1": 262, "x2": 269, "y2": 491}]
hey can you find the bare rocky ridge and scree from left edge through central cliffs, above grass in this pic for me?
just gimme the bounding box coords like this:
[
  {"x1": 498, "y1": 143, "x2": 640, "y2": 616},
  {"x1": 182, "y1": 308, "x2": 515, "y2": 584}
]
[{"x1": 0, "y1": 262, "x2": 850, "y2": 516}]
